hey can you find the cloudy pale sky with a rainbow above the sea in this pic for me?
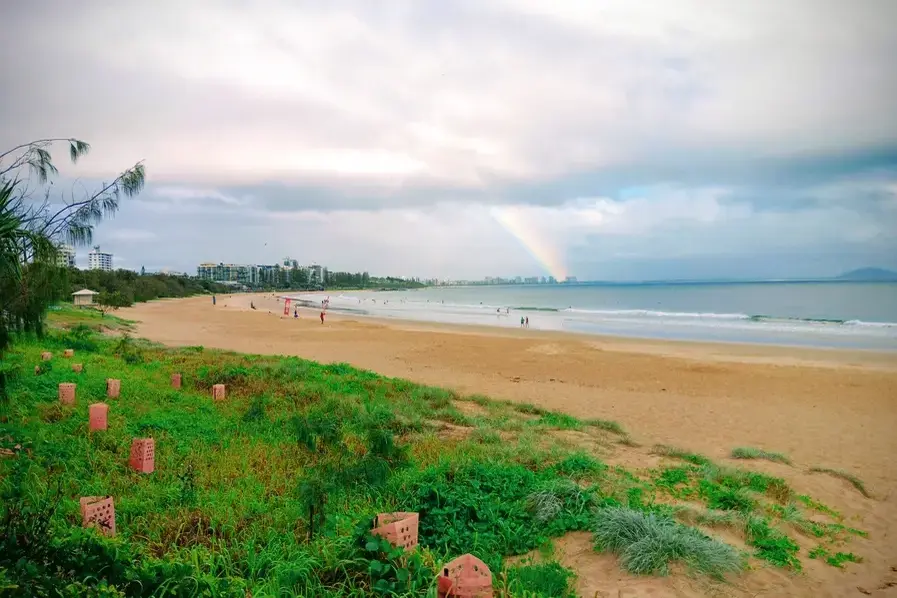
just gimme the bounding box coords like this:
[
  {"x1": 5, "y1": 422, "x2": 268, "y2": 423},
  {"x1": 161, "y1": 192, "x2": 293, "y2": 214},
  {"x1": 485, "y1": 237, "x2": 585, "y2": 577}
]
[{"x1": 0, "y1": 0, "x2": 897, "y2": 280}]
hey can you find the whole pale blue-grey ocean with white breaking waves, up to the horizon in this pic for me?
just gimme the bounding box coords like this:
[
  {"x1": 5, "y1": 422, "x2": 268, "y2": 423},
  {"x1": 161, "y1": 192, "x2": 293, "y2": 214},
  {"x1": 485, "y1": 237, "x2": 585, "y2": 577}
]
[{"x1": 293, "y1": 281, "x2": 897, "y2": 351}]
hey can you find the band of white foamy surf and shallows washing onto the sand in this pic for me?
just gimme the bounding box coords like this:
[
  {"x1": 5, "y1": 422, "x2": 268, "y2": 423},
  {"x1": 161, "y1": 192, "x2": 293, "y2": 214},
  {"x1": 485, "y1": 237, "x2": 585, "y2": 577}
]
[{"x1": 276, "y1": 291, "x2": 897, "y2": 356}]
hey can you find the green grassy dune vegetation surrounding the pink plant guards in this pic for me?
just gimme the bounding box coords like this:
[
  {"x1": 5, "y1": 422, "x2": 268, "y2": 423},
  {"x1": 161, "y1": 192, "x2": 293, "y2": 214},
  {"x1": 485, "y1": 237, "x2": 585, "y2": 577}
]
[{"x1": 0, "y1": 310, "x2": 861, "y2": 597}]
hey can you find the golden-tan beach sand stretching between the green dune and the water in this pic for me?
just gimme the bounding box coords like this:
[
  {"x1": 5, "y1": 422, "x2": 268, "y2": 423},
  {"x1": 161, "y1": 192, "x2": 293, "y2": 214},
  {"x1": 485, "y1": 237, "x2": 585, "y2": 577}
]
[{"x1": 117, "y1": 294, "x2": 897, "y2": 598}]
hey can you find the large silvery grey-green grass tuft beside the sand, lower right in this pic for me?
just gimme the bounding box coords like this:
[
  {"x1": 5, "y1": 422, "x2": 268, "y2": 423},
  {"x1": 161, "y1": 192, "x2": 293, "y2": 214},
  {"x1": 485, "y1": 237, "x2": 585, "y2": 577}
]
[{"x1": 594, "y1": 507, "x2": 744, "y2": 578}]
